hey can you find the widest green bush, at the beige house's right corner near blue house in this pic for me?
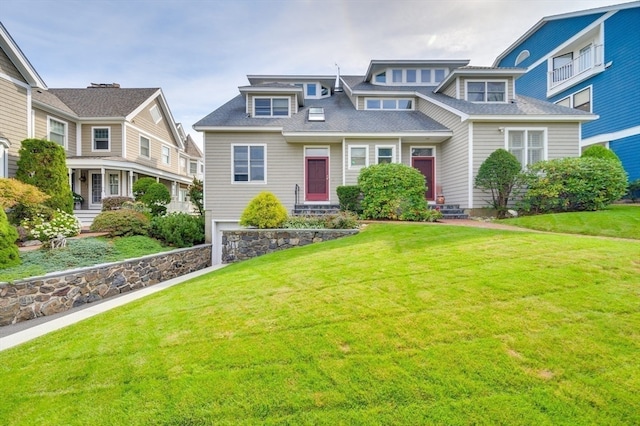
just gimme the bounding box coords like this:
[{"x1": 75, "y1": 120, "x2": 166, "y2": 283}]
[{"x1": 519, "y1": 157, "x2": 627, "y2": 213}]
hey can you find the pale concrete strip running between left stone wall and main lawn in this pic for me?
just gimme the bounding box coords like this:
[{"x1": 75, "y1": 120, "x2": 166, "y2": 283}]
[{"x1": 0, "y1": 265, "x2": 226, "y2": 351}]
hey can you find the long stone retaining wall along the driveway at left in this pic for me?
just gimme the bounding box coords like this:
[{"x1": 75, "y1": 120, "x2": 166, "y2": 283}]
[{"x1": 0, "y1": 244, "x2": 211, "y2": 326}]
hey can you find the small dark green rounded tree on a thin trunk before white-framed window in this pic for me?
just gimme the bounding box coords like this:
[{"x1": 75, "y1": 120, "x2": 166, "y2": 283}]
[{"x1": 475, "y1": 148, "x2": 522, "y2": 219}]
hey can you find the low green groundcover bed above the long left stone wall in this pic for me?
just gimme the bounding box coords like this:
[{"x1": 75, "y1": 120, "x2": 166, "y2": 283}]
[{"x1": 0, "y1": 235, "x2": 172, "y2": 282}]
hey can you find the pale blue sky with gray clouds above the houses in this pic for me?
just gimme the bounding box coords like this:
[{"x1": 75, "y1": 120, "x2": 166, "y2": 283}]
[{"x1": 0, "y1": 0, "x2": 636, "y2": 146}]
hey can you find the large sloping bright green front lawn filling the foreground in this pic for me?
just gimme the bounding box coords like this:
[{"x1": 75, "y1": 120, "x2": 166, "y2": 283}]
[{"x1": 0, "y1": 224, "x2": 640, "y2": 425}]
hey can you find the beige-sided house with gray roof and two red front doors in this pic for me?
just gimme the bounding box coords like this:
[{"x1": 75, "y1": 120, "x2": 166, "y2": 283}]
[{"x1": 194, "y1": 60, "x2": 597, "y2": 246}]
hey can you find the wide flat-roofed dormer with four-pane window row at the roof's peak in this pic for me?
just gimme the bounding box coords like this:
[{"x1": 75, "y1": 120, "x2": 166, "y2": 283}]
[{"x1": 365, "y1": 60, "x2": 469, "y2": 86}]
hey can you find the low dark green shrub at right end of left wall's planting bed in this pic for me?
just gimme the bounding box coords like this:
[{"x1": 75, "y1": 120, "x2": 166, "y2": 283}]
[{"x1": 150, "y1": 213, "x2": 204, "y2": 247}]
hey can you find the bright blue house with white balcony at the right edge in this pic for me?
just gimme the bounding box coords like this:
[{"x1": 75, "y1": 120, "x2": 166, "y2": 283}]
[{"x1": 493, "y1": 1, "x2": 640, "y2": 181}]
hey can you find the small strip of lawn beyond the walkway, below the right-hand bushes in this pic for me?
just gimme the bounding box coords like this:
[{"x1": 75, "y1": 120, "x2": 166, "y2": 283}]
[{"x1": 500, "y1": 205, "x2": 640, "y2": 240}]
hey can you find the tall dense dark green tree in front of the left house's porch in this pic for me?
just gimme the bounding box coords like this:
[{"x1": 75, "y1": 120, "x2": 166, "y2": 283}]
[{"x1": 16, "y1": 139, "x2": 73, "y2": 214}]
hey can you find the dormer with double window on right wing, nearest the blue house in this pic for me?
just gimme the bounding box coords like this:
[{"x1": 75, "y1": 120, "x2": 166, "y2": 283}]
[{"x1": 434, "y1": 66, "x2": 526, "y2": 103}]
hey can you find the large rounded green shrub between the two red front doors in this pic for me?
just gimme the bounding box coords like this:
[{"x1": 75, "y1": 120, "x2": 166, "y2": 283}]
[{"x1": 358, "y1": 163, "x2": 427, "y2": 220}]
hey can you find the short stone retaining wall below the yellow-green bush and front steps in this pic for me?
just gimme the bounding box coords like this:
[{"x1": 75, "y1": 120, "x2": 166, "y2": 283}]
[{"x1": 222, "y1": 229, "x2": 358, "y2": 263}]
